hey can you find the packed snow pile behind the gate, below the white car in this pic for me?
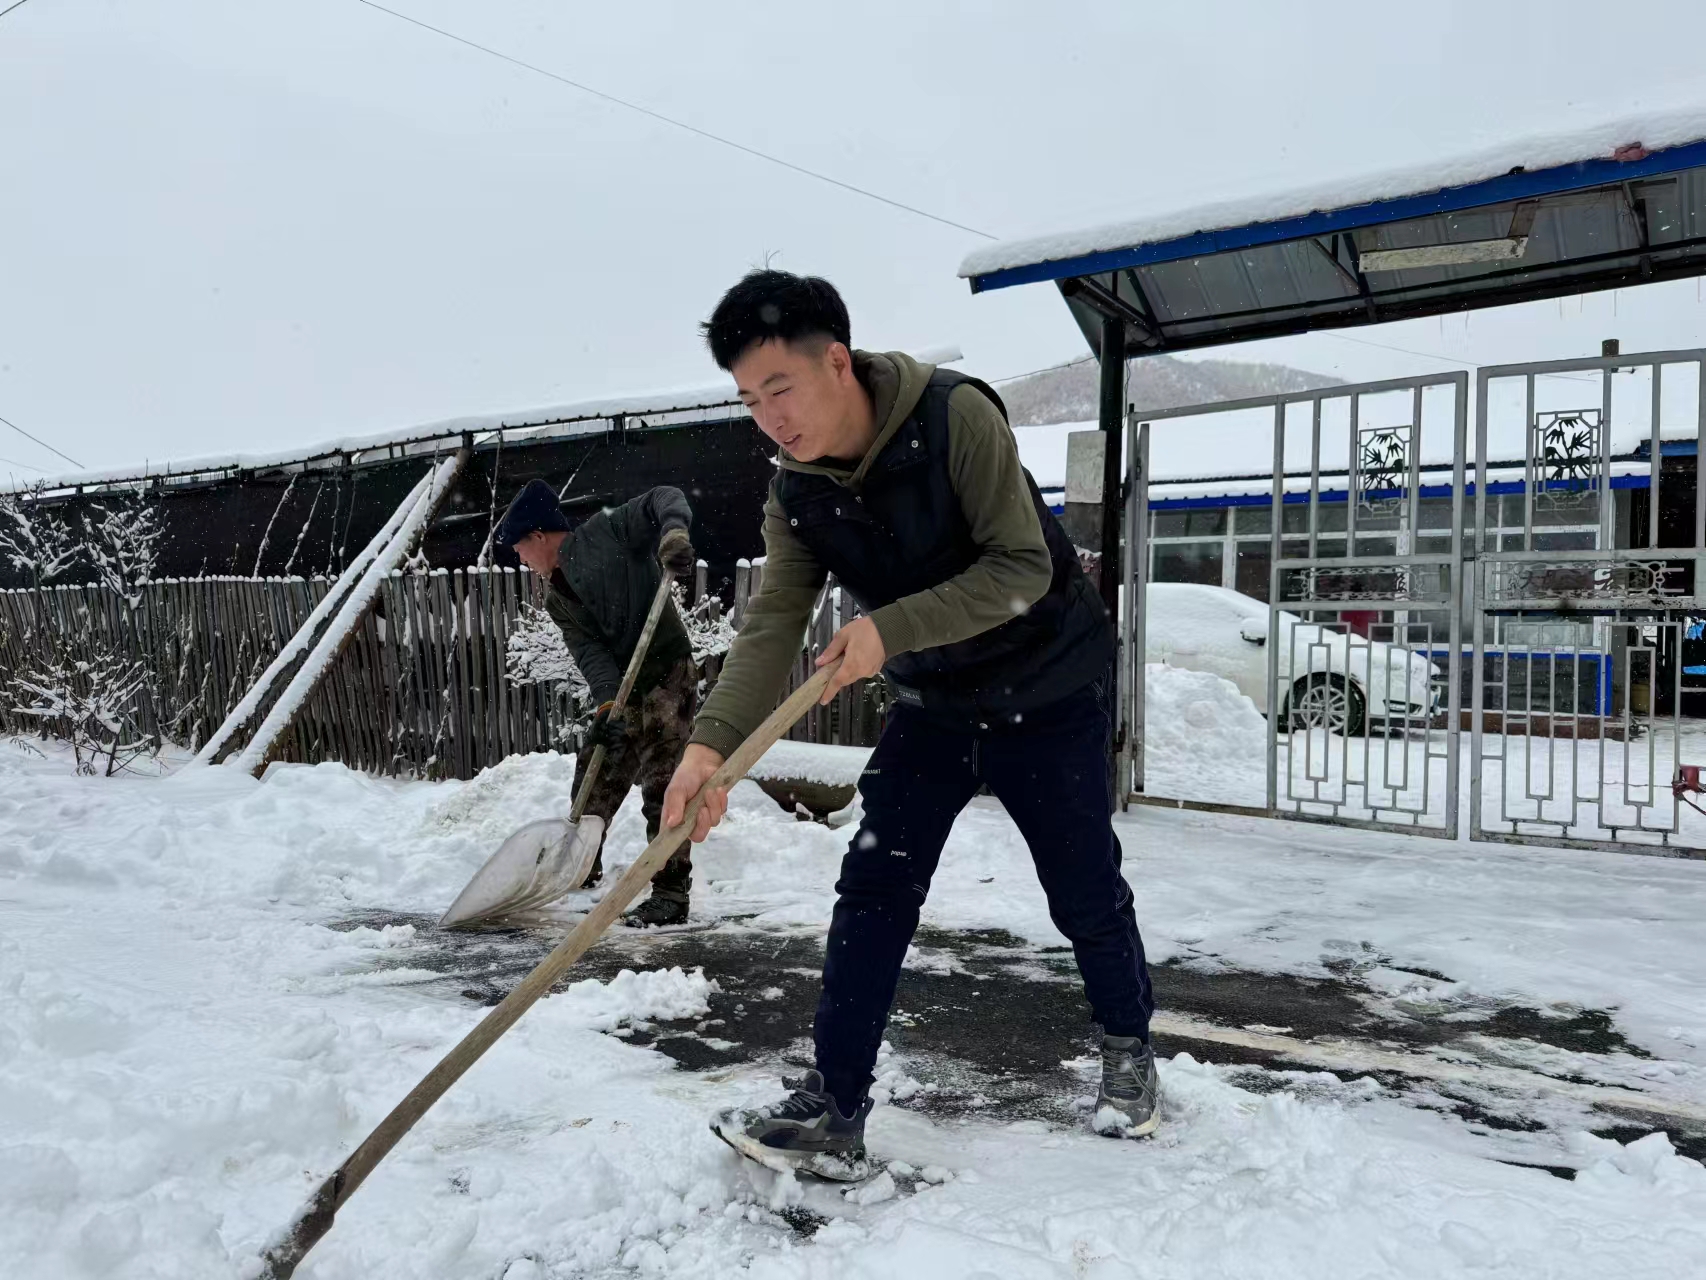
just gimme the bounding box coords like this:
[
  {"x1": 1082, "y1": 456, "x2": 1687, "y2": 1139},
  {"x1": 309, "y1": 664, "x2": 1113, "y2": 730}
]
[{"x1": 1143, "y1": 662, "x2": 1268, "y2": 804}]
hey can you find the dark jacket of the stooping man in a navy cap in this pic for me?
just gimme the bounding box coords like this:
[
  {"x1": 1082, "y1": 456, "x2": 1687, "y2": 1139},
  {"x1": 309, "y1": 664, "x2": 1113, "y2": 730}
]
[{"x1": 544, "y1": 485, "x2": 693, "y2": 703}]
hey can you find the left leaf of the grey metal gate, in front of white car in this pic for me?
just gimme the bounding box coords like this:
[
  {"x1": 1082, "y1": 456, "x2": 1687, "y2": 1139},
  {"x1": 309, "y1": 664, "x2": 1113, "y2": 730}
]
[{"x1": 1119, "y1": 374, "x2": 1469, "y2": 838}]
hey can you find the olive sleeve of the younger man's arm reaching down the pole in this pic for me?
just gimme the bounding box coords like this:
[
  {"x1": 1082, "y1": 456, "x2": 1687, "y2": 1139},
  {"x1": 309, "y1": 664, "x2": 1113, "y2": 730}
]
[{"x1": 693, "y1": 492, "x2": 827, "y2": 759}]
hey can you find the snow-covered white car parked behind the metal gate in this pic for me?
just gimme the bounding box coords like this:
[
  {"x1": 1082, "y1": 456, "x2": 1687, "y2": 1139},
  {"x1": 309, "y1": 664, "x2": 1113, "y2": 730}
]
[{"x1": 1145, "y1": 582, "x2": 1442, "y2": 736}]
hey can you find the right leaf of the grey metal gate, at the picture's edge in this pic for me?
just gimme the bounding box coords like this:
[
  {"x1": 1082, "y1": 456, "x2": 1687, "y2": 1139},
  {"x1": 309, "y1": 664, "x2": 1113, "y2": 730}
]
[{"x1": 1469, "y1": 350, "x2": 1706, "y2": 857}]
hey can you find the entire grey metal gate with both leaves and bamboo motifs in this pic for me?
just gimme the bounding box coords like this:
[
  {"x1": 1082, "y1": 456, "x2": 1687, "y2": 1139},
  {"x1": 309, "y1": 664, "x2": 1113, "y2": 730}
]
[{"x1": 1119, "y1": 350, "x2": 1706, "y2": 857}]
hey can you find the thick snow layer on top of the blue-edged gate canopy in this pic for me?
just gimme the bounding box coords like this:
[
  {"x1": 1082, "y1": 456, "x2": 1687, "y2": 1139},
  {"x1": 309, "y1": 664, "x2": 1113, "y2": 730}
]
[{"x1": 959, "y1": 106, "x2": 1706, "y2": 278}]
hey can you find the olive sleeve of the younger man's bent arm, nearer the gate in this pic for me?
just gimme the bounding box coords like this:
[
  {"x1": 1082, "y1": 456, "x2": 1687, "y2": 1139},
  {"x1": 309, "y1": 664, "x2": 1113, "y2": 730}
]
[{"x1": 870, "y1": 386, "x2": 1053, "y2": 657}]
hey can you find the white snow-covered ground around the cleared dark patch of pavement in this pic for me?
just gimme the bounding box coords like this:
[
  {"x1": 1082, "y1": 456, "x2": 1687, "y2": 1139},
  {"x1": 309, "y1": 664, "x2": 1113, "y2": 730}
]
[{"x1": 0, "y1": 725, "x2": 1706, "y2": 1280}]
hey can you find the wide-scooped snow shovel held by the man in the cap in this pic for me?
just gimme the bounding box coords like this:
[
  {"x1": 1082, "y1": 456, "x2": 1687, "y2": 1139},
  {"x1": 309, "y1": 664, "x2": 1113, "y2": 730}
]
[{"x1": 438, "y1": 570, "x2": 676, "y2": 928}]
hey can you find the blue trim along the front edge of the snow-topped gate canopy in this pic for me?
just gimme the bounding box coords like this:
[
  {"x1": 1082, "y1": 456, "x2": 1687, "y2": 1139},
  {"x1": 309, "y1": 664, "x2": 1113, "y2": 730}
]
[{"x1": 971, "y1": 140, "x2": 1706, "y2": 294}]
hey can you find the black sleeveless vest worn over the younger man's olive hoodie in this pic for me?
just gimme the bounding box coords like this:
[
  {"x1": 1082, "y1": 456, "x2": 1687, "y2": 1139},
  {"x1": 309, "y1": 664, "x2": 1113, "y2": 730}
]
[{"x1": 775, "y1": 369, "x2": 1114, "y2": 720}]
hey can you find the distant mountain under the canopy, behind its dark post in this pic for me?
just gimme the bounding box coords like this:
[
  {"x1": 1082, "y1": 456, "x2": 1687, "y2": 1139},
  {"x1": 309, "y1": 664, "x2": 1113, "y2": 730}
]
[{"x1": 996, "y1": 355, "x2": 1341, "y2": 427}]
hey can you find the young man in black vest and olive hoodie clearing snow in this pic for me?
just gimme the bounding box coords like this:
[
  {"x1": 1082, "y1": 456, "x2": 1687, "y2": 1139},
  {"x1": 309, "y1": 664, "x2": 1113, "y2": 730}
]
[{"x1": 664, "y1": 271, "x2": 1160, "y2": 1176}]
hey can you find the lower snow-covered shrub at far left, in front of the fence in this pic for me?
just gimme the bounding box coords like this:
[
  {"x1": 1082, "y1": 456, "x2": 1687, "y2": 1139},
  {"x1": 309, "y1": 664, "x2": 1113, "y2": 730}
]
[{"x1": 3, "y1": 637, "x2": 160, "y2": 777}]
